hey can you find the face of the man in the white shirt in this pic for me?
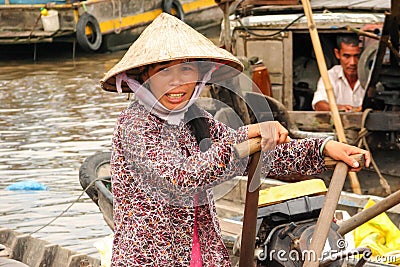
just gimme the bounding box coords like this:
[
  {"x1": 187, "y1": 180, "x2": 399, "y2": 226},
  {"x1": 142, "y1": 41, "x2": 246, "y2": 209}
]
[{"x1": 335, "y1": 43, "x2": 360, "y2": 78}]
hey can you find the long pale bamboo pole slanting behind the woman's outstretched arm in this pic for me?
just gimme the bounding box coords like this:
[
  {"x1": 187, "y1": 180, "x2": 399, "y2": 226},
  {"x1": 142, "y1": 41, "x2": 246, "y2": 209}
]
[{"x1": 301, "y1": 0, "x2": 361, "y2": 194}]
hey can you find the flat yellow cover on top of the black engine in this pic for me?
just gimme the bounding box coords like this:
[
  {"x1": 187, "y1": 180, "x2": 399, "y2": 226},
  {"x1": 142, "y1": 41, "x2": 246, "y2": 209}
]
[{"x1": 258, "y1": 179, "x2": 327, "y2": 207}]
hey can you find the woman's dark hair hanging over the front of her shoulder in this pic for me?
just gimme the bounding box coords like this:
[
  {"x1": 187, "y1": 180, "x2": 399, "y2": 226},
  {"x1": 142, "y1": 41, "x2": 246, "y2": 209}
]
[{"x1": 184, "y1": 104, "x2": 212, "y2": 152}]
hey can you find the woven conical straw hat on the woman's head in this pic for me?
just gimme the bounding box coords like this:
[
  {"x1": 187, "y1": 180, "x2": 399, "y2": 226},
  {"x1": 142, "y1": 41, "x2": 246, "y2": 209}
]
[{"x1": 100, "y1": 13, "x2": 243, "y2": 92}]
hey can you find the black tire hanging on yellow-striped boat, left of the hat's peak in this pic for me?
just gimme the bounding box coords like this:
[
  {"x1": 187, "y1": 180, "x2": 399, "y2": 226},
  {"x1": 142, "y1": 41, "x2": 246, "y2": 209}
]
[{"x1": 76, "y1": 13, "x2": 103, "y2": 52}]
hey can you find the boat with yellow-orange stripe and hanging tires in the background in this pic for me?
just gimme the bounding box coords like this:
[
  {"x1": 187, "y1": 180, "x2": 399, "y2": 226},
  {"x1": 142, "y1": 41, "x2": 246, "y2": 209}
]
[{"x1": 0, "y1": 0, "x2": 222, "y2": 51}]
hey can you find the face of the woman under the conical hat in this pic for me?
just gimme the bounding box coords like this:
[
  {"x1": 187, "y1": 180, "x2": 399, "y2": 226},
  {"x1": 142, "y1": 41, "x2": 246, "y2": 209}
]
[{"x1": 146, "y1": 60, "x2": 199, "y2": 110}]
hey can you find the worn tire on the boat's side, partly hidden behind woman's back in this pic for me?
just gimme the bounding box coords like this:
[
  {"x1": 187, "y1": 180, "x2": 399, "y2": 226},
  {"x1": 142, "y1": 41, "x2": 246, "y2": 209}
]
[{"x1": 79, "y1": 152, "x2": 111, "y2": 205}]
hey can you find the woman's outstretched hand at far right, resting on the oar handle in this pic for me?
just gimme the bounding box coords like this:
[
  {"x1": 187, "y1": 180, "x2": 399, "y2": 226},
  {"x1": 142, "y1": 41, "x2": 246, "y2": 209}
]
[{"x1": 323, "y1": 140, "x2": 371, "y2": 171}]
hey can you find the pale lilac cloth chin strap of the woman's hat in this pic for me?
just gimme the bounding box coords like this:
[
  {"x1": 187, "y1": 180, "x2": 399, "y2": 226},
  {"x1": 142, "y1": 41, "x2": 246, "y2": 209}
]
[{"x1": 116, "y1": 65, "x2": 217, "y2": 125}]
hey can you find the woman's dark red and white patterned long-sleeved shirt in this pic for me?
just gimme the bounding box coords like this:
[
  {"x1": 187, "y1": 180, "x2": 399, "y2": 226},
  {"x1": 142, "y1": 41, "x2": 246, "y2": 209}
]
[{"x1": 111, "y1": 101, "x2": 325, "y2": 267}]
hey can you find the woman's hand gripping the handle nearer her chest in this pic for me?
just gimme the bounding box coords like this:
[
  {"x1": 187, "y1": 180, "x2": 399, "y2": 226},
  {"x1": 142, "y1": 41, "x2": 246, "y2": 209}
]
[{"x1": 248, "y1": 121, "x2": 290, "y2": 151}]
